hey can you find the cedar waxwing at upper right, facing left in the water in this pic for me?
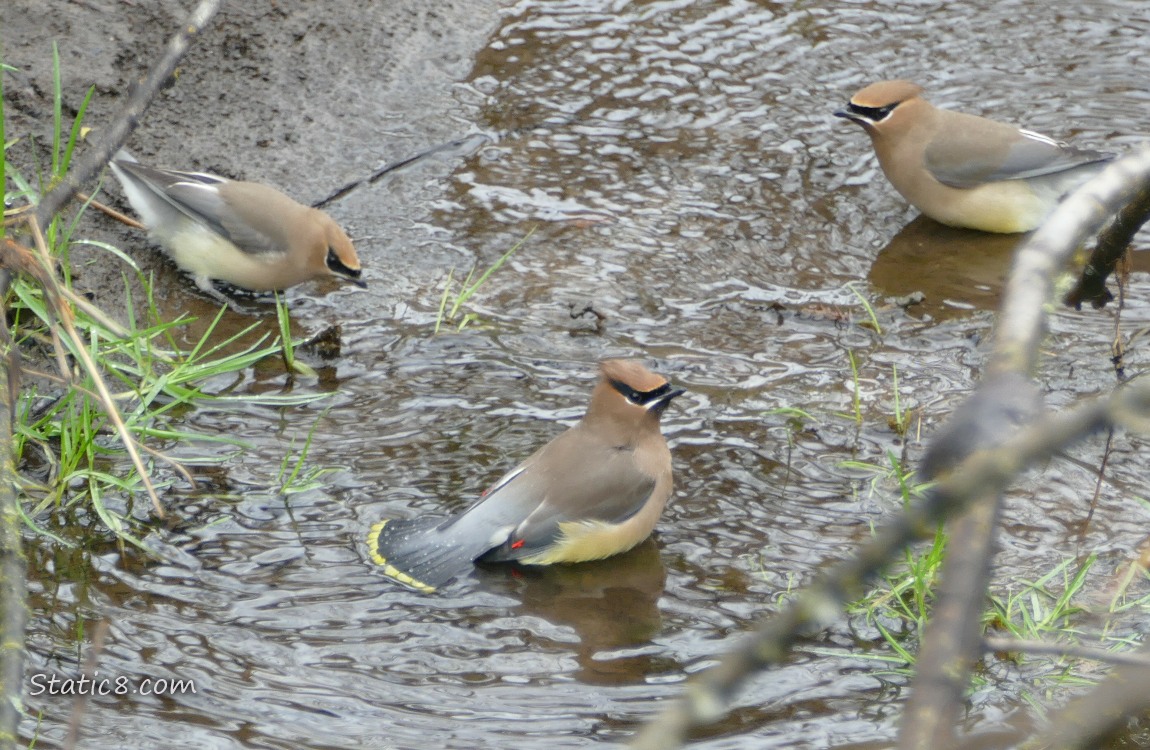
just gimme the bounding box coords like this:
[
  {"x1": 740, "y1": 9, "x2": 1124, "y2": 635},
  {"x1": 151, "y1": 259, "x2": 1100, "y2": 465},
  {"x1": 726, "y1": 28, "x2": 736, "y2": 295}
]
[{"x1": 835, "y1": 81, "x2": 1113, "y2": 232}]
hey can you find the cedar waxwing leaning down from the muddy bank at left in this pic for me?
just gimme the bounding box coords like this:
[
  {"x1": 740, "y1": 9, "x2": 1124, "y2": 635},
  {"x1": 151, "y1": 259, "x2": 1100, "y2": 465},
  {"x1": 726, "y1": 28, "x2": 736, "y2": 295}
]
[{"x1": 110, "y1": 151, "x2": 367, "y2": 299}]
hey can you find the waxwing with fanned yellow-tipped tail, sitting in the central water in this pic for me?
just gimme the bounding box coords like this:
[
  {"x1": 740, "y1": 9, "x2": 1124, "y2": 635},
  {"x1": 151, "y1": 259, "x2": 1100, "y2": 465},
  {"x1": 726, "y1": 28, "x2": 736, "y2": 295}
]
[{"x1": 368, "y1": 359, "x2": 683, "y2": 592}]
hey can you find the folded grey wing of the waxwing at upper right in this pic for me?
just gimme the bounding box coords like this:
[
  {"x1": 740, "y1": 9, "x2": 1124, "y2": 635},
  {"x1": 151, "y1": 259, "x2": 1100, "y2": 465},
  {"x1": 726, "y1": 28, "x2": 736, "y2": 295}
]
[{"x1": 923, "y1": 121, "x2": 1113, "y2": 188}]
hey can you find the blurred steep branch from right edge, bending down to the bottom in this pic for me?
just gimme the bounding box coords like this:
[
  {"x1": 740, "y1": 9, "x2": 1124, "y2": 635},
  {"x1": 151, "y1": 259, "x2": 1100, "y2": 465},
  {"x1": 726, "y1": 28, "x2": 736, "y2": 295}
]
[{"x1": 899, "y1": 151, "x2": 1150, "y2": 750}]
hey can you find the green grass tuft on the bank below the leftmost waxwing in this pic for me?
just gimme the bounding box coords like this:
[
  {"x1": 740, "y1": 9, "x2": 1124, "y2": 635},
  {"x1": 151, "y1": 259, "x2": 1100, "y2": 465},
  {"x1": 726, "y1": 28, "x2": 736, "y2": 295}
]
[{"x1": 0, "y1": 48, "x2": 324, "y2": 549}]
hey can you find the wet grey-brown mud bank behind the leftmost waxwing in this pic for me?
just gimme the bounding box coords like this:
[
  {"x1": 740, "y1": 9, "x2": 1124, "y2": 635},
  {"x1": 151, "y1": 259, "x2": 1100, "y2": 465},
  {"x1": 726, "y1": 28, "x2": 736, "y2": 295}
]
[{"x1": 0, "y1": 0, "x2": 496, "y2": 311}]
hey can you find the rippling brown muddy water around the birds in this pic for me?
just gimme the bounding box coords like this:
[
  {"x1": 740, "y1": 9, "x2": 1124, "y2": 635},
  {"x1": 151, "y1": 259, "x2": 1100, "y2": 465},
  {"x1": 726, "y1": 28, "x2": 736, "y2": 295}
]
[{"x1": 20, "y1": 0, "x2": 1150, "y2": 748}]
